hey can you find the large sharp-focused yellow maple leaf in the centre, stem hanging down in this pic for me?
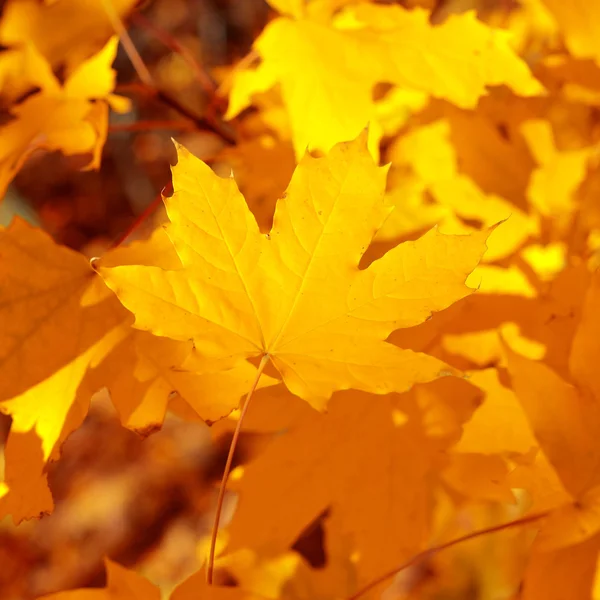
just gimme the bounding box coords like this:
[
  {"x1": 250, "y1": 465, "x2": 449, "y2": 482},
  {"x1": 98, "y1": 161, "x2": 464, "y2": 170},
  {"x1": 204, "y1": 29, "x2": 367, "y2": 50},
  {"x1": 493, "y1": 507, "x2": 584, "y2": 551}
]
[{"x1": 99, "y1": 135, "x2": 488, "y2": 408}]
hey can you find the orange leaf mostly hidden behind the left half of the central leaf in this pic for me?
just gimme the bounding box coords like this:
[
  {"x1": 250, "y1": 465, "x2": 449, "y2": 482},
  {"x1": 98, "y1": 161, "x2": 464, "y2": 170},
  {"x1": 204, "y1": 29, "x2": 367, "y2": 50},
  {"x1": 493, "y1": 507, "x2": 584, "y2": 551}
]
[{"x1": 89, "y1": 228, "x2": 276, "y2": 426}]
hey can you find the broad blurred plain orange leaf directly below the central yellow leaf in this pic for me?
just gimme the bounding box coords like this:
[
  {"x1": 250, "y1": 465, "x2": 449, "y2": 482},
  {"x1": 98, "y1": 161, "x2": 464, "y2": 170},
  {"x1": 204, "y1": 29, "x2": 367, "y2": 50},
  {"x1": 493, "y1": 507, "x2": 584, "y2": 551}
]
[{"x1": 218, "y1": 377, "x2": 479, "y2": 591}]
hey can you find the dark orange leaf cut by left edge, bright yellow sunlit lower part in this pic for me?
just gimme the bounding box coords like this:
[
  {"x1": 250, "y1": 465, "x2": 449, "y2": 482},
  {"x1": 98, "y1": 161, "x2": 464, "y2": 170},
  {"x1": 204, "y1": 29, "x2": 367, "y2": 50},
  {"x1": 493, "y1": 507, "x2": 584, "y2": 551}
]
[{"x1": 0, "y1": 219, "x2": 123, "y2": 459}]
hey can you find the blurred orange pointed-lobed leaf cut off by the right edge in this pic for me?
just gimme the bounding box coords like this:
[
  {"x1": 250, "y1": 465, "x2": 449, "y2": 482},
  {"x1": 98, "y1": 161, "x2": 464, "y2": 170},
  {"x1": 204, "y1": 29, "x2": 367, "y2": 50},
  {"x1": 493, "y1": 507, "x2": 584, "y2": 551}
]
[{"x1": 507, "y1": 274, "x2": 600, "y2": 550}]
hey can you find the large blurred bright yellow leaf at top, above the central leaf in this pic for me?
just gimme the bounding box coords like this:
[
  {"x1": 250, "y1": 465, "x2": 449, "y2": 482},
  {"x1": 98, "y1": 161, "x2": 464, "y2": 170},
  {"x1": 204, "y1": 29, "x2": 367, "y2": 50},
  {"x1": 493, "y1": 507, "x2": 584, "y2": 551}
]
[{"x1": 226, "y1": 3, "x2": 543, "y2": 157}]
